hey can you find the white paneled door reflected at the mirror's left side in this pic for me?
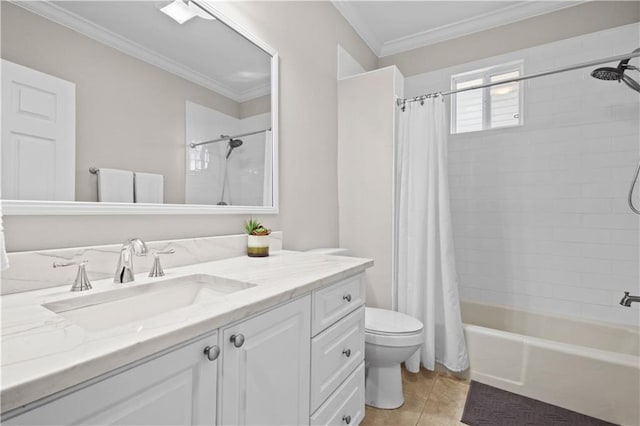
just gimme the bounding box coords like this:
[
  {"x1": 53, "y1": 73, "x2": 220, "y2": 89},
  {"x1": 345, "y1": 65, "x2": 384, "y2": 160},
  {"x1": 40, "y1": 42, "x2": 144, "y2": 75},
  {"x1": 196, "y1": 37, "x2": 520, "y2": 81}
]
[{"x1": 0, "y1": 59, "x2": 76, "y2": 201}]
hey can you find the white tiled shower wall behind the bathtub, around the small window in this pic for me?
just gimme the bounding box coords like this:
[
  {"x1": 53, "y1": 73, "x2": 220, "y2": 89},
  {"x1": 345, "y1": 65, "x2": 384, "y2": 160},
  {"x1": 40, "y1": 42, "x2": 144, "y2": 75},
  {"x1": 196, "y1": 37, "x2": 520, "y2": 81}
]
[{"x1": 406, "y1": 24, "x2": 640, "y2": 325}]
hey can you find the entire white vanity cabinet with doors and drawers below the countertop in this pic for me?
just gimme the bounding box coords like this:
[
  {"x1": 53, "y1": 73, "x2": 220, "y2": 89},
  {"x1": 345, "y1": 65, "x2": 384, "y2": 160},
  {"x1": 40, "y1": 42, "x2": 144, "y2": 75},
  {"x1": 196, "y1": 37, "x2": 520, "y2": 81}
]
[{"x1": 3, "y1": 274, "x2": 365, "y2": 425}]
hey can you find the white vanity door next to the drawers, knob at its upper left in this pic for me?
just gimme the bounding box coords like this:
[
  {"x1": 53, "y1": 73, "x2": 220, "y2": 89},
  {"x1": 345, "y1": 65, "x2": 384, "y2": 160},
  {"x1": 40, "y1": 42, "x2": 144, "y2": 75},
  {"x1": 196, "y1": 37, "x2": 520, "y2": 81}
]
[{"x1": 218, "y1": 296, "x2": 311, "y2": 425}]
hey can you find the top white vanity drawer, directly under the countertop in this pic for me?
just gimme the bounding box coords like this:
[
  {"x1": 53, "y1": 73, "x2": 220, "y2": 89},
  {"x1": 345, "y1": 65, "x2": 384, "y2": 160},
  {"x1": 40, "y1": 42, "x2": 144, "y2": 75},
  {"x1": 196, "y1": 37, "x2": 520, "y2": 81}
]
[{"x1": 311, "y1": 274, "x2": 365, "y2": 336}]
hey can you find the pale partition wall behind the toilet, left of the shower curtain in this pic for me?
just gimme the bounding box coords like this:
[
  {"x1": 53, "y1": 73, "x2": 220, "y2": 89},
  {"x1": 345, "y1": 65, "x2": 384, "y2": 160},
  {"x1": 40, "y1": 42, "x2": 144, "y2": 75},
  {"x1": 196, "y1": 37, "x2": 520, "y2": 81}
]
[{"x1": 338, "y1": 67, "x2": 404, "y2": 309}]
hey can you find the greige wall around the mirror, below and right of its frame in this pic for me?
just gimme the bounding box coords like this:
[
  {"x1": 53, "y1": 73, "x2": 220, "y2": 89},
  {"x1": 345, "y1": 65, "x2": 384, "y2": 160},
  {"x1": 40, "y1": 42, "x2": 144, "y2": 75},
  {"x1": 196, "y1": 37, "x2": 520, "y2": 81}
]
[{"x1": 4, "y1": 2, "x2": 377, "y2": 252}]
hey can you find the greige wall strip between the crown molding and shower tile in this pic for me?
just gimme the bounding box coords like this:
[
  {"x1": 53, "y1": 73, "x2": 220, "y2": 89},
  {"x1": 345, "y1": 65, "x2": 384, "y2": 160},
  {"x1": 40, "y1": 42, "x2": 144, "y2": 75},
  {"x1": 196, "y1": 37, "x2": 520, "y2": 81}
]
[{"x1": 378, "y1": 1, "x2": 640, "y2": 77}]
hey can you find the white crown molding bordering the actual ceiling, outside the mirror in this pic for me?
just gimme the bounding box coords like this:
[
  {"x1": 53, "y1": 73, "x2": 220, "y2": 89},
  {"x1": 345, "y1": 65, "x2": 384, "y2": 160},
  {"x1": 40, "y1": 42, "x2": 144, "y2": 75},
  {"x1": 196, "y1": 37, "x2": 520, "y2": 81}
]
[{"x1": 332, "y1": 0, "x2": 590, "y2": 58}]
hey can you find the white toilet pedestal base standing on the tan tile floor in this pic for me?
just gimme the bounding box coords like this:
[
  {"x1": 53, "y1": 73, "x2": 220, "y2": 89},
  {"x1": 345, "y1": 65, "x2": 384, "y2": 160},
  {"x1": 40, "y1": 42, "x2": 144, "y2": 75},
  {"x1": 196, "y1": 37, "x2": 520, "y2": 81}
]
[{"x1": 364, "y1": 364, "x2": 404, "y2": 410}]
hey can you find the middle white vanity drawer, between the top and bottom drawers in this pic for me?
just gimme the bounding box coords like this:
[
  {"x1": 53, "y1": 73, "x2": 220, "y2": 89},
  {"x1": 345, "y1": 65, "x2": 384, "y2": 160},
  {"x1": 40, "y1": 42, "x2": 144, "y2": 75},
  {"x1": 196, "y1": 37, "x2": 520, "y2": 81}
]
[{"x1": 311, "y1": 306, "x2": 364, "y2": 412}]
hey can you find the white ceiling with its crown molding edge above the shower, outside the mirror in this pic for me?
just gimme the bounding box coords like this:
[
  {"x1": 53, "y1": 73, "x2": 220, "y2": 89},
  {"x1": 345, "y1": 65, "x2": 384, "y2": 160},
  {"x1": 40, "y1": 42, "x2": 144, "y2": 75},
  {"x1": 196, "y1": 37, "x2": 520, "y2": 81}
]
[{"x1": 333, "y1": 0, "x2": 583, "y2": 57}]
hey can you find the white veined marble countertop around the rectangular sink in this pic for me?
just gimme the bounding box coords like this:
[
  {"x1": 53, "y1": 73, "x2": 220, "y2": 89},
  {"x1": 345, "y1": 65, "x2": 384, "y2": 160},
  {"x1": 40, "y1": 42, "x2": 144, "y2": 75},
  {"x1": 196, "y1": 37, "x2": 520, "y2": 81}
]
[{"x1": 0, "y1": 251, "x2": 373, "y2": 413}]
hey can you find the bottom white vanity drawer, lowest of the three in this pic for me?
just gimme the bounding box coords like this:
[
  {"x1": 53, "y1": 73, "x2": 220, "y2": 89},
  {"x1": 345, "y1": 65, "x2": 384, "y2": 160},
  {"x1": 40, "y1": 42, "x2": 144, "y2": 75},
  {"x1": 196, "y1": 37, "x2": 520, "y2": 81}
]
[{"x1": 310, "y1": 362, "x2": 364, "y2": 426}]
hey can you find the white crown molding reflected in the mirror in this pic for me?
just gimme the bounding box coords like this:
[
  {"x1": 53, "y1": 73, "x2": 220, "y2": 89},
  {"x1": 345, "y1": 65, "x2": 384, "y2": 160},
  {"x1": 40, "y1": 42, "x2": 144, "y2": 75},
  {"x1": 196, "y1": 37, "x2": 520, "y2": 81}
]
[{"x1": 10, "y1": 0, "x2": 260, "y2": 102}]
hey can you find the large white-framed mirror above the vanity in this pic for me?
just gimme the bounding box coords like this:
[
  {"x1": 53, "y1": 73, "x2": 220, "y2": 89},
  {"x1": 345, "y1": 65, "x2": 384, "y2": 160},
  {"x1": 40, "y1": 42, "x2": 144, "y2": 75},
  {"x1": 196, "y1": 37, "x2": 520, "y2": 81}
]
[{"x1": 1, "y1": 0, "x2": 278, "y2": 215}]
